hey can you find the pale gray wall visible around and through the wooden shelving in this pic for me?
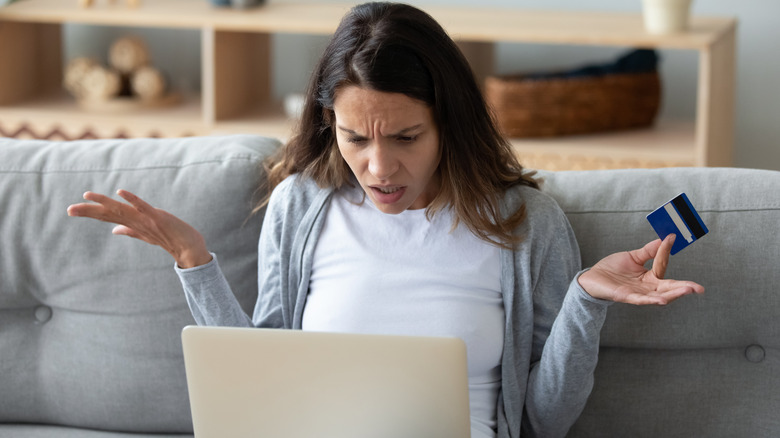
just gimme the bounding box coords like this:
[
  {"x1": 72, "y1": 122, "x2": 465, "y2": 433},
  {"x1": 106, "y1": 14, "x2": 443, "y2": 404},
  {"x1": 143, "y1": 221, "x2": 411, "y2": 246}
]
[{"x1": 65, "y1": 0, "x2": 780, "y2": 170}]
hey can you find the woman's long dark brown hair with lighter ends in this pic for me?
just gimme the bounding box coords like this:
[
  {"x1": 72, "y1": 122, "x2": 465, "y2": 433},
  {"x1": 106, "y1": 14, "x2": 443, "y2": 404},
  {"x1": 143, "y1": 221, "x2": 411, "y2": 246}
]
[{"x1": 264, "y1": 2, "x2": 539, "y2": 248}]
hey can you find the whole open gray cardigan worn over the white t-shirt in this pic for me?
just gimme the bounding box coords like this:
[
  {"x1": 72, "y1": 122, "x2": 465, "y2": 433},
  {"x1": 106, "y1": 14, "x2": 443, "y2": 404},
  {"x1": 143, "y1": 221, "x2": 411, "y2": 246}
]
[{"x1": 176, "y1": 176, "x2": 609, "y2": 438}]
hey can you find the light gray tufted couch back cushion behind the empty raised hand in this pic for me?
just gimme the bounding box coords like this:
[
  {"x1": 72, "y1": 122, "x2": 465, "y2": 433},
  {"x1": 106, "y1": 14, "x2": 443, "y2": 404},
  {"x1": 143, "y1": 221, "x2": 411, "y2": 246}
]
[{"x1": 0, "y1": 136, "x2": 278, "y2": 432}]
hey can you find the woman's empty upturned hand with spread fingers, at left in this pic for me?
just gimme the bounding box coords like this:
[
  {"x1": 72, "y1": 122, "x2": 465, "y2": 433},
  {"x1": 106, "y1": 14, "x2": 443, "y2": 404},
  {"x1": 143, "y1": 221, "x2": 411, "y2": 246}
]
[{"x1": 68, "y1": 190, "x2": 211, "y2": 268}]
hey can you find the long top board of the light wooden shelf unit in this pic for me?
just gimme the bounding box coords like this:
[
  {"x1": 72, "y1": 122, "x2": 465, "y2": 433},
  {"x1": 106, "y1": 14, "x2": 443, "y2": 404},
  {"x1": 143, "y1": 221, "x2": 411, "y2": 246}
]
[{"x1": 0, "y1": 0, "x2": 736, "y2": 45}]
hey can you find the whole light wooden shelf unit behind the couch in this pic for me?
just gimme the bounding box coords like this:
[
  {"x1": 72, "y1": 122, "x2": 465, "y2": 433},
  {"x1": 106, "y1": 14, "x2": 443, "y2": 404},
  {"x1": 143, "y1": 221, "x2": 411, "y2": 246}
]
[{"x1": 0, "y1": 0, "x2": 736, "y2": 169}]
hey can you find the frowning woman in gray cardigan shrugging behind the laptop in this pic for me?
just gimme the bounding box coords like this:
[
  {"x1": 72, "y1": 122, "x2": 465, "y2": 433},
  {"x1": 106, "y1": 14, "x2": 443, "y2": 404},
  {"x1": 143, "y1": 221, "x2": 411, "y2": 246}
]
[{"x1": 68, "y1": 3, "x2": 703, "y2": 438}]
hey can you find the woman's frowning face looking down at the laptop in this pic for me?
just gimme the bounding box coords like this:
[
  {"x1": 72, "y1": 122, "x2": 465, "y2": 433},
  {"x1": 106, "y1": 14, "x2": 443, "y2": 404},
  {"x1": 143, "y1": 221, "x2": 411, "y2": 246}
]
[{"x1": 333, "y1": 86, "x2": 441, "y2": 214}]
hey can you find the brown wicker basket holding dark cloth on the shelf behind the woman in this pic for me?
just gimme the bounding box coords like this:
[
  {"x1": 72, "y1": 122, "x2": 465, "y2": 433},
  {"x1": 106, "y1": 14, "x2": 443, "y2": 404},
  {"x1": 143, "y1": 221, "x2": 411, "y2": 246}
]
[{"x1": 485, "y1": 71, "x2": 661, "y2": 137}]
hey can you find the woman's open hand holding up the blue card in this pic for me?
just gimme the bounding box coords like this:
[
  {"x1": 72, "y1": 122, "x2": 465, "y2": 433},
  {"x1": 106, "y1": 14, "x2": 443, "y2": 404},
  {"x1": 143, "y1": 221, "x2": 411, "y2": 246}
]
[{"x1": 579, "y1": 234, "x2": 704, "y2": 305}]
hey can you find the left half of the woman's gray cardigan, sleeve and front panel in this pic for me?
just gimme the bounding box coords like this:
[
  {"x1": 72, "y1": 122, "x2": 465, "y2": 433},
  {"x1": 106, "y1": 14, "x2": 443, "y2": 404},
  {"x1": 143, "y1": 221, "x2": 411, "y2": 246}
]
[{"x1": 176, "y1": 175, "x2": 331, "y2": 329}]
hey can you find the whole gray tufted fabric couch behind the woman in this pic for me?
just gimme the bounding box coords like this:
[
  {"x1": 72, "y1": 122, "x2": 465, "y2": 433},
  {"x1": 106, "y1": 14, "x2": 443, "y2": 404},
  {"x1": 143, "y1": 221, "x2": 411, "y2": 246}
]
[{"x1": 0, "y1": 136, "x2": 780, "y2": 438}]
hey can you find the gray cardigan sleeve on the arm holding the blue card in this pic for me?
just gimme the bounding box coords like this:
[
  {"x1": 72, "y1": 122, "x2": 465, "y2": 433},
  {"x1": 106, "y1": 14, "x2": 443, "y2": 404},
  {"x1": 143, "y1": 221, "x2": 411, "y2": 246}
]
[{"x1": 522, "y1": 193, "x2": 611, "y2": 437}]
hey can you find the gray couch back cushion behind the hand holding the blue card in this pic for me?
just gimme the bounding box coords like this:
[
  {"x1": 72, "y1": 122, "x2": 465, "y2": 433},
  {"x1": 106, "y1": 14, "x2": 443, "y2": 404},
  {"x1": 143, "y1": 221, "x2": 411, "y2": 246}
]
[{"x1": 544, "y1": 168, "x2": 780, "y2": 438}]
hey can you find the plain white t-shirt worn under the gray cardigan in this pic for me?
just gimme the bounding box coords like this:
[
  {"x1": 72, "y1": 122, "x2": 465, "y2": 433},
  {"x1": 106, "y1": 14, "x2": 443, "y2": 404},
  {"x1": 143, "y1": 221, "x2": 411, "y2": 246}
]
[{"x1": 302, "y1": 187, "x2": 505, "y2": 438}]
